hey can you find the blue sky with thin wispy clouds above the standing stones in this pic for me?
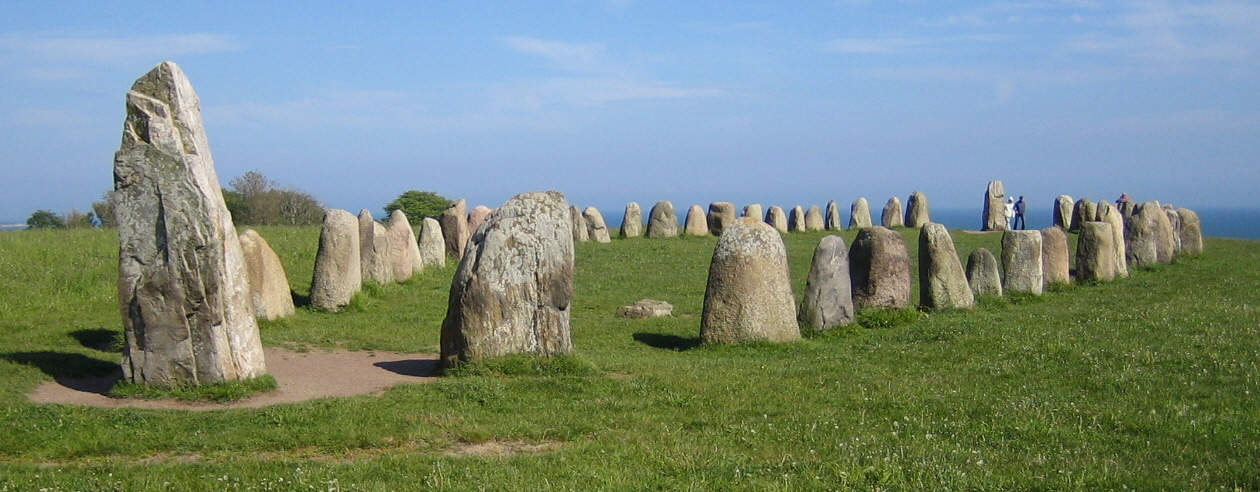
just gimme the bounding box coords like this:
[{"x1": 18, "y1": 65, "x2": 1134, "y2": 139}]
[{"x1": 0, "y1": 0, "x2": 1260, "y2": 222}]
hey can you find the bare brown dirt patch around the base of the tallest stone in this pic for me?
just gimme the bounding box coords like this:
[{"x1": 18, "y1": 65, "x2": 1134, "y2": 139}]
[{"x1": 29, "y1": 348, "x2": 437, "y2": 410}]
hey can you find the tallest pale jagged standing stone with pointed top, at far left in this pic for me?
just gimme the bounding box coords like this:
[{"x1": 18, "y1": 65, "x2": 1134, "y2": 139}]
[{"x1": 113, "y1": 62, "x2": 266, "y2": 386}]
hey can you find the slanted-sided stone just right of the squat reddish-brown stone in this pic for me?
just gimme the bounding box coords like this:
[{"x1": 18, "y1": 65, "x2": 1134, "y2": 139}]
[{"x1": 919, "y1": 222, "x2": 975, "y2": 309}]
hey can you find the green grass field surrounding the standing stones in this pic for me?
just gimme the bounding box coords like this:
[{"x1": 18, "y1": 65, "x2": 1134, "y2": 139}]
[{"x1": 0, "y1": 224, "x2": 1260, "y2": 491}]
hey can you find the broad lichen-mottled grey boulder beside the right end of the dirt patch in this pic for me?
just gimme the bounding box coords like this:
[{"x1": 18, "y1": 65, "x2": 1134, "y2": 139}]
[{"x1": 441, "y1": 192, "x2": 573, "y2": 368}]
